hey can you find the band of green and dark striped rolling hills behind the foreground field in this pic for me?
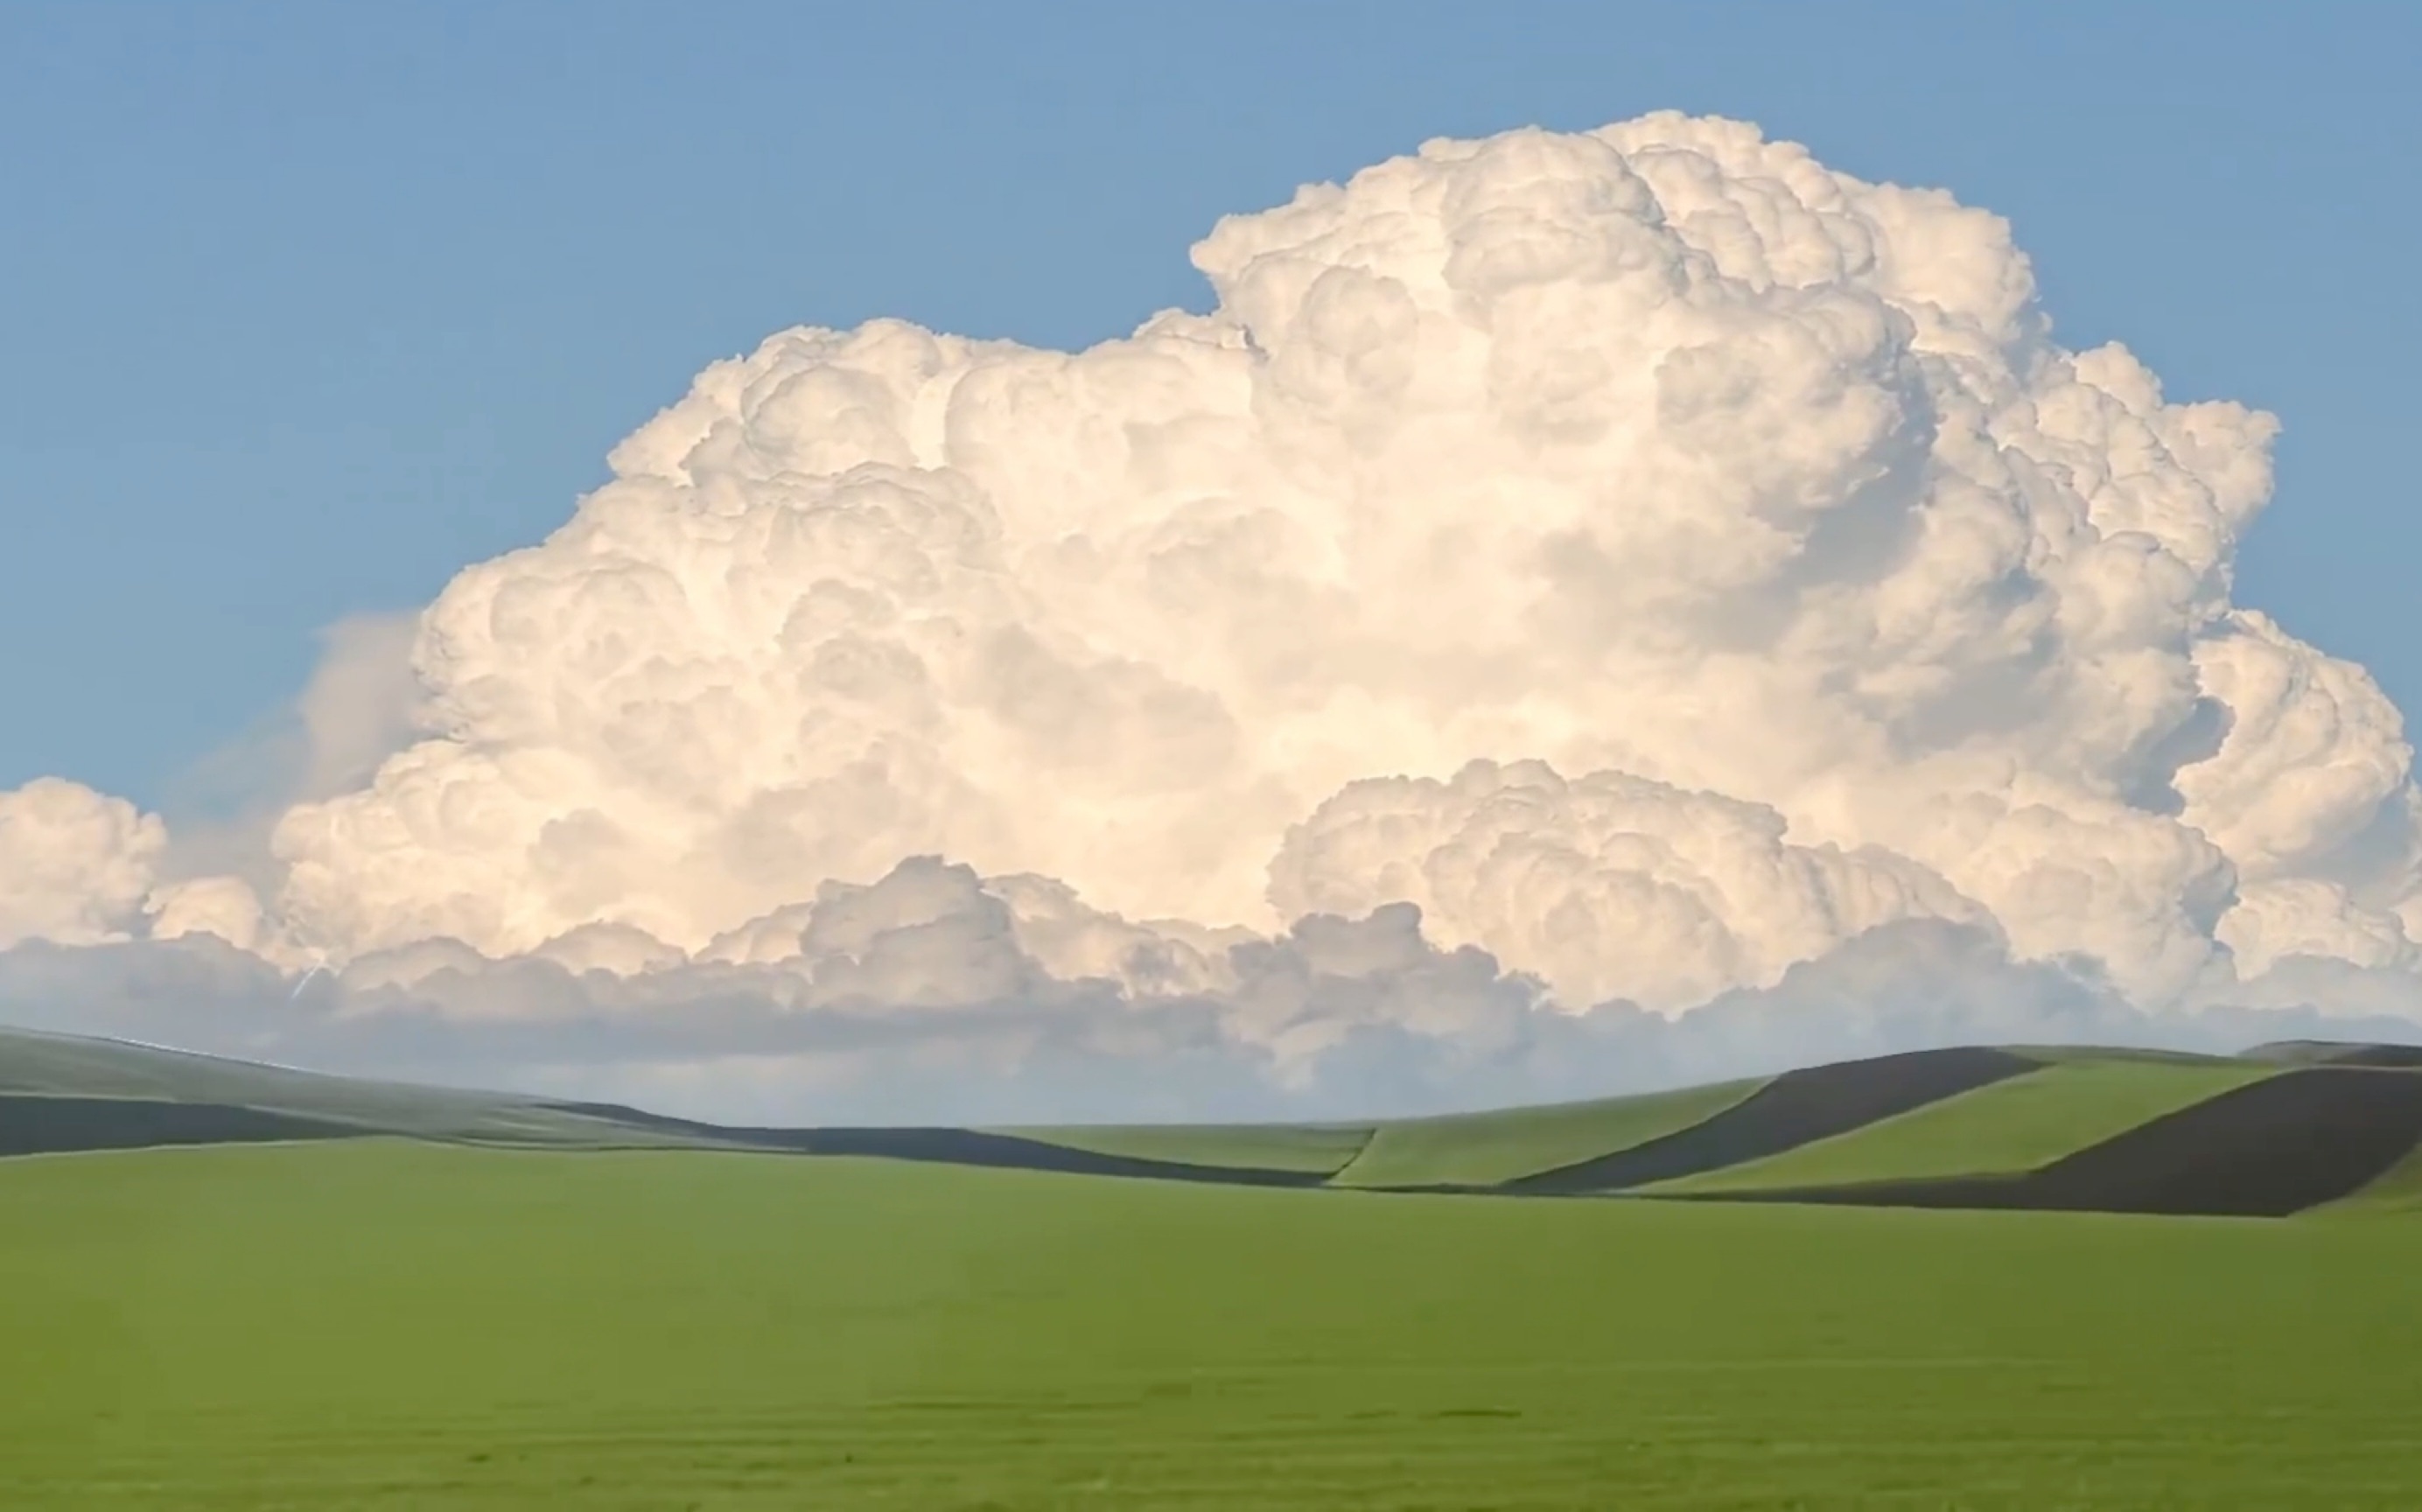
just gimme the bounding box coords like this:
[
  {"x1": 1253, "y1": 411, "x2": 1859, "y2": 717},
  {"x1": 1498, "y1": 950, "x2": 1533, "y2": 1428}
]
[{"x1": 0, "y1": 1032, "x2": 2422, "y2": 1216}]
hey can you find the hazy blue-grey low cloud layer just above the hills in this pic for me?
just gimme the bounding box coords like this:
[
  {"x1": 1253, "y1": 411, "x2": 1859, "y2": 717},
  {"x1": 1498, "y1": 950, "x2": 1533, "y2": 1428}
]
[{"x1": 0, "y1": 886, "x2": 2422, "y2": 1124}]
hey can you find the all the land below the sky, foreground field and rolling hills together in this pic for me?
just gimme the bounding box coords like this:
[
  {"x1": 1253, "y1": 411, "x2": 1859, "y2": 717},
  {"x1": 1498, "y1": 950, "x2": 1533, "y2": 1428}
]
[{"x1": 0, "y1": 1032, "x2": 2422, "y2": 1512}]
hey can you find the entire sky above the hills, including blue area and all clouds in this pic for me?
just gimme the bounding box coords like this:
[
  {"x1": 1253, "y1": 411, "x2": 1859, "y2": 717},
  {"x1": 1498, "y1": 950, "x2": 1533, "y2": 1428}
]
[{"x1": 0, "y1": 0, "x2": 2422, "y2": 1122}]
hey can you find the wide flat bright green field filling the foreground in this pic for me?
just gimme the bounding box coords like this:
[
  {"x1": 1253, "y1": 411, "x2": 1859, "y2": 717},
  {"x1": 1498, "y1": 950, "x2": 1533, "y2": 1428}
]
[{"x1": 0, "y1": 1141, "x2": 2422, "y2": 1512}]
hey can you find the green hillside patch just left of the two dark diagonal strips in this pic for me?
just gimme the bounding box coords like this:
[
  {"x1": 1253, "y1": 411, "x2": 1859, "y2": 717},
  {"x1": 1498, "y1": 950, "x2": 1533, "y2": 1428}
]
[{"x1": 1332, "y1": 1081, "x2": 1763, "y2": 1187}]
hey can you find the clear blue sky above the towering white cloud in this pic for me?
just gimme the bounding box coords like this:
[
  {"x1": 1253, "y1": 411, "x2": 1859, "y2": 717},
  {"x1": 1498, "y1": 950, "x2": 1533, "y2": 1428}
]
[{"x1": 0, "y1": 0, "x2": 2422, "y2": 807}]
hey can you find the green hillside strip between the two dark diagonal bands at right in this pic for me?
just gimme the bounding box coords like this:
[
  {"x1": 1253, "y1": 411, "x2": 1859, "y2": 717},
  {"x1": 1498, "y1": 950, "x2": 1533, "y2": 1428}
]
[{"x1": 1644, "y1": 1056, "x2": 2277, "y2": 1192}]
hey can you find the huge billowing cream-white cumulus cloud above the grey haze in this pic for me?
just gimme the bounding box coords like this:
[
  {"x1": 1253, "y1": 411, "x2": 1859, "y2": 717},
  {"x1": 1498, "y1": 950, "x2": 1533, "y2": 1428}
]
[{"x1": 0, "y1": 114, "x2": 2422, "y2": 1114}]
